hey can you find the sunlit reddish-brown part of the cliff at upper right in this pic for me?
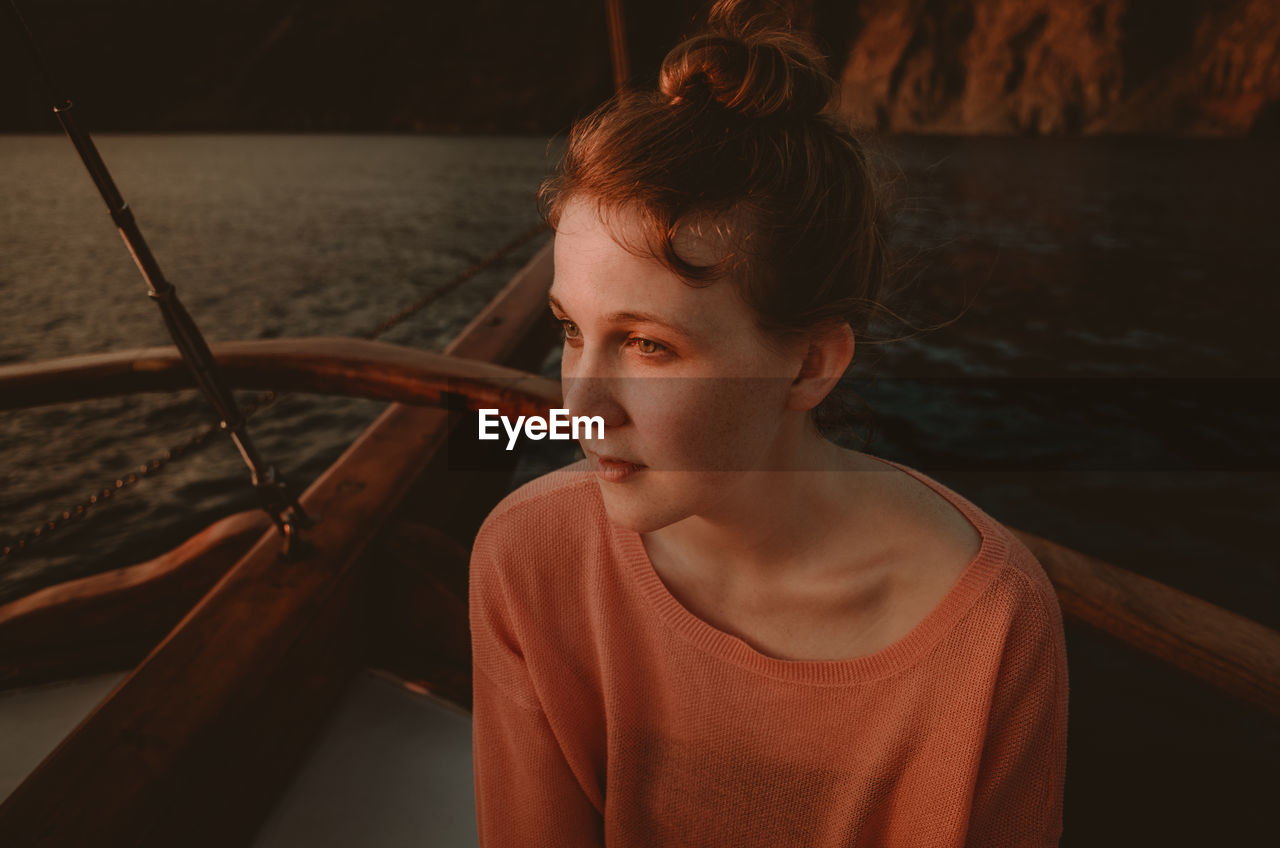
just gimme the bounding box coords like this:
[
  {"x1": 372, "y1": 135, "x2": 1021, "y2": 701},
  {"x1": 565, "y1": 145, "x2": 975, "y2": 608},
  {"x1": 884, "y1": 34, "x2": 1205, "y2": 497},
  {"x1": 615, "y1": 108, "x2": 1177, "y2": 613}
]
[{"x1": 834, "y1": 0, "x2": 1280, "y2": 135}]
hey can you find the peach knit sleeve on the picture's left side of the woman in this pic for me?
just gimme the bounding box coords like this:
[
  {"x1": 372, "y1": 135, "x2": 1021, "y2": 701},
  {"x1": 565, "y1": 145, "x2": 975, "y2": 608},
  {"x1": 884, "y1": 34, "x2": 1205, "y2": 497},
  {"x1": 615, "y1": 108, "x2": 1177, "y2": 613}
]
[{"x1": 470, "y1": 517, "x2": 604, "y2": 848}]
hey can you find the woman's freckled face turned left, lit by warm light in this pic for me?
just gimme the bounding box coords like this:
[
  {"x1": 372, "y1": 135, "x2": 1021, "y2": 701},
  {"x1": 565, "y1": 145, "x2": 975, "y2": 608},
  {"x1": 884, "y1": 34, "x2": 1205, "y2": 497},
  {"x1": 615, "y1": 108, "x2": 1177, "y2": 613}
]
[{"x1": 550, "y1": 199, "x2": 806, "y2": 533}]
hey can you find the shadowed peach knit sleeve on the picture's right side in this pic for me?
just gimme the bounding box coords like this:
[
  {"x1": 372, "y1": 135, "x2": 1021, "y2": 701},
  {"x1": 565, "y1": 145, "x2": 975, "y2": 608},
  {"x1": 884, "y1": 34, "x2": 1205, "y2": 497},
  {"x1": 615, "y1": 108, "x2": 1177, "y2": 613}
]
[{"x1": 965, "y1": 573, "x2": 1068, "y2": 848}]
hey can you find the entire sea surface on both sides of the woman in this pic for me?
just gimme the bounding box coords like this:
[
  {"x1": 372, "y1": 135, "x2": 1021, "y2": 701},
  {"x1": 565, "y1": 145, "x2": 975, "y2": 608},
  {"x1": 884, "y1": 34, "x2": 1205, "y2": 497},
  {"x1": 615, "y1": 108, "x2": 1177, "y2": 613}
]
[{"x1": 0, "y1": 135, "x2": 1280, "y2": 844}]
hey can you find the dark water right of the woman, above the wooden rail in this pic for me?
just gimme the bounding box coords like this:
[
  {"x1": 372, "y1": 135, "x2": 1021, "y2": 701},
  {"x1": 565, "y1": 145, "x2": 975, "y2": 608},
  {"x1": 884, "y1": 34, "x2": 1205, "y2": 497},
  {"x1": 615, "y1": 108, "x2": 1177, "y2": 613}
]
[{"x1": 860, "y1": 138, "x2": 1280, "y2": 626}]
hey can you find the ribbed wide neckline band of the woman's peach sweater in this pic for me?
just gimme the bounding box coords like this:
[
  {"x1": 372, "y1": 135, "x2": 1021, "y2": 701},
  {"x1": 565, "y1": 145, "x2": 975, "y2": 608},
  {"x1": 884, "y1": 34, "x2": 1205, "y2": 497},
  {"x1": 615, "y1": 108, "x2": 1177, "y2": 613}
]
[{"x1": 614, "y1": 453, "x2": 1009, "y2": 685}]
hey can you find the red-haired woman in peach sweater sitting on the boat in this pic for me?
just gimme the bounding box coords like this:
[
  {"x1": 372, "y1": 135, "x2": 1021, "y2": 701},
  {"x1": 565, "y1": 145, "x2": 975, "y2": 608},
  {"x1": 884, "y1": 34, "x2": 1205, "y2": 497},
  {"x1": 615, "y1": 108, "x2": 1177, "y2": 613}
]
[{"x1": 471, "y1": 3, "x2": 1066, "y2": 848}]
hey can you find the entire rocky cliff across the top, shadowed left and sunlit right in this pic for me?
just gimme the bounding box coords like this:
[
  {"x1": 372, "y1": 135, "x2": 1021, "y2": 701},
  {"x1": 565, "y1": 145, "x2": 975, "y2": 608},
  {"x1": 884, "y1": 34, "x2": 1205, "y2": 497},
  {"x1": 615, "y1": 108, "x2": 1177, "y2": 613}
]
[{"x1": 0, "y1": 0, "x2": 1280, "y2": 136}]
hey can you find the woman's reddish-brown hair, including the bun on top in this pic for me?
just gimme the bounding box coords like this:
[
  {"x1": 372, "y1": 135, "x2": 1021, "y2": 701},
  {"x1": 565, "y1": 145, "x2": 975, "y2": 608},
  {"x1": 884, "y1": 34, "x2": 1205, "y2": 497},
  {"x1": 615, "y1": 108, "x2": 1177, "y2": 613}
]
[{"x1": 539, "y1": 0, "x2": 887, "y2": 438}]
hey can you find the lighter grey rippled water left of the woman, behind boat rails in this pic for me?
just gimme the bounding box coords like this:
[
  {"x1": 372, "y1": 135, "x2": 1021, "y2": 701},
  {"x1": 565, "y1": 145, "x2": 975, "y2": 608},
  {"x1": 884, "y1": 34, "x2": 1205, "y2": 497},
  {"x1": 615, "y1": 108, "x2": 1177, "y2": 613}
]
[{"x1": 0, "y1": 136, "x2": 547, "y2": 602}]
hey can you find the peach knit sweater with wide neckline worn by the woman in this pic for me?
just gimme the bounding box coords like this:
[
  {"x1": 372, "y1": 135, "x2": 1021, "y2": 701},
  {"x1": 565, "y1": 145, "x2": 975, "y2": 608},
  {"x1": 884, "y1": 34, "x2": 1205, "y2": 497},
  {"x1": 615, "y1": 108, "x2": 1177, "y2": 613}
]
[{"x1": 470, "y1": 464, "x2": 1066, "y2": 848}]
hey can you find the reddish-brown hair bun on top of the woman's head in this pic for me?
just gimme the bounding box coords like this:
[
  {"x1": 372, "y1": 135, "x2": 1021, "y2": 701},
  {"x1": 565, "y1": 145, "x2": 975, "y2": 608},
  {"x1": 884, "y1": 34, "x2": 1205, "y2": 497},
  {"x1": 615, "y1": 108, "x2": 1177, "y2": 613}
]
[{"x1": 658, "y1": 17, "x2": 835, "y2": 118}]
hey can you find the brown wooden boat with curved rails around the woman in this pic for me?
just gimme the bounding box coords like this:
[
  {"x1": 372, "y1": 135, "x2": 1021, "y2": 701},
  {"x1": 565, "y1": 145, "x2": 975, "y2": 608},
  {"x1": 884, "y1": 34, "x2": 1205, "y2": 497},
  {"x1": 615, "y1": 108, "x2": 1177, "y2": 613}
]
[{"x1": 0, "y1": 4, "x2": 1280, "y2": 847}]
